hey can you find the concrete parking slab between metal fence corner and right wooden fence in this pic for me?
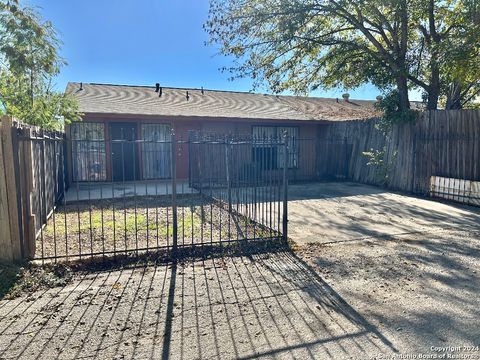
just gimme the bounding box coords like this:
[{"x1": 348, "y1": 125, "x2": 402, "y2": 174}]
[{"x1": 288, "y1": 182, "x2": 480, "y2": 245}]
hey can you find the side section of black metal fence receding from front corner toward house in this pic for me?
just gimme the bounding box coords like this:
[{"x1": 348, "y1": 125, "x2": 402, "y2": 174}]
[{"x1": 189, "y1": 132, "x2": 293, "y2": 246}]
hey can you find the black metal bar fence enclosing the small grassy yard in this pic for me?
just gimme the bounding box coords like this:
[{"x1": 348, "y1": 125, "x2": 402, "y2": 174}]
[{"x1": 18, "y1": 127, "x2": 286, "y2": 261}]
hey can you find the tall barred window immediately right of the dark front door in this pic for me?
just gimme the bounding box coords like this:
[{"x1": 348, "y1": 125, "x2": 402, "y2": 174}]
[{"x1": 142, "y1": 124, "x2": 171, "y2": 179}]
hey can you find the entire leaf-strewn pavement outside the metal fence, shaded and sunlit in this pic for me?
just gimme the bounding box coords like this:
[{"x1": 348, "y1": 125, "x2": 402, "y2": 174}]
[{"x1": 0, "y1": 183, "x2": 480, "y2": 359}]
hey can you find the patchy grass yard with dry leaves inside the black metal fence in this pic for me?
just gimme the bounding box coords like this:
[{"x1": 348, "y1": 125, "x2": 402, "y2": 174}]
[{"x1": 35, "y1": 194, "x2": 277, "y2": 260}]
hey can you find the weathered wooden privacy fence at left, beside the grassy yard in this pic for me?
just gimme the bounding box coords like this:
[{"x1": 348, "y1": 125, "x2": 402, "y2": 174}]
[{"x1": 0, "y1": 117, "x2": 66, "y2": 261}]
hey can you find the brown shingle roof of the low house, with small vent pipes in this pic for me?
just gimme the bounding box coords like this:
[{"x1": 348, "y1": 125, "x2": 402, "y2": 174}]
[{"x1": 66, "y1": 82, "x2": 378, "y2": 121}]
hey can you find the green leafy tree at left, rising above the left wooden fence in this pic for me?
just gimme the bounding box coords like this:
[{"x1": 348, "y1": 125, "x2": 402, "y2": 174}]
[{"x1": 0, "y1": 0, "x2": 79, "y2": 129}]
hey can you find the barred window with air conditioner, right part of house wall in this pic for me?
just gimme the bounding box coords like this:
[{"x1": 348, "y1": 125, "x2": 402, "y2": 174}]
[{"x1": 252, "y1": 126, "x2": 298, "y2": 170}]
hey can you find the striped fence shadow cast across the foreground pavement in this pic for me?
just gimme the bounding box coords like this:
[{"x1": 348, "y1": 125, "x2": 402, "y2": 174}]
[{"x1": 0, "y1": 250, "x2": 396, "y2": 359}]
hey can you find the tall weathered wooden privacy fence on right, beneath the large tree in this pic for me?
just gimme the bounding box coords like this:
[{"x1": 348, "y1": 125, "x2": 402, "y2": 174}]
[{"x1": 317, "y1": 110, "x2": 480, "y2": 200}]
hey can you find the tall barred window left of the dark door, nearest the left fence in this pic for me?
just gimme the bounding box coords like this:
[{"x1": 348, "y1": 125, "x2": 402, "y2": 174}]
[{"x1": 71, "y1": 122, "x2": 107, "y2": 181}]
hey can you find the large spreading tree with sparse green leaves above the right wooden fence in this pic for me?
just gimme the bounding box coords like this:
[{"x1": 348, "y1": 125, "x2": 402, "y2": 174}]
[{"x1": 205, "y1": 0, "x2": 480, "y2": 110}]
